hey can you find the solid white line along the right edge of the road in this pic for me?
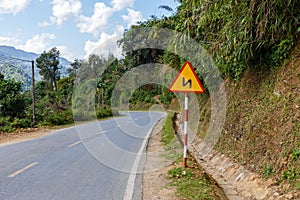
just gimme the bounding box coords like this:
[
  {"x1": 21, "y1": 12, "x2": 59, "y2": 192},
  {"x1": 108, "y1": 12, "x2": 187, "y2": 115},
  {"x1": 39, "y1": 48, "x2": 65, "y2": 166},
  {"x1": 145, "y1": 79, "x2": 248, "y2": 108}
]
[{"x1": 123, "y1": 115, "x2": 160, "y2": 200}]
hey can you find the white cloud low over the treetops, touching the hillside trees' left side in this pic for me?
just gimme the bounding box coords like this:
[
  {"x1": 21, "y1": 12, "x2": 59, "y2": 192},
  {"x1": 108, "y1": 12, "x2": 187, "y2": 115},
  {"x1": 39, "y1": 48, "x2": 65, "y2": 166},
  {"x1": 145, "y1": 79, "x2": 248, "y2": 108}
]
[{"x1": 84, "y1": 26, "x2": 124, "y2": 58}]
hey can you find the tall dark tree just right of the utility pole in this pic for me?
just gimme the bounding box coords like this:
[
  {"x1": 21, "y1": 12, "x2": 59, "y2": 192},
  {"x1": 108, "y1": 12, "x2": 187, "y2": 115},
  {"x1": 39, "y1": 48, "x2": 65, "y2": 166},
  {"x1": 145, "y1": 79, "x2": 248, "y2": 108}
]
[{"x1": 36, "y1": 47, "x2": 60, "y2": 91}]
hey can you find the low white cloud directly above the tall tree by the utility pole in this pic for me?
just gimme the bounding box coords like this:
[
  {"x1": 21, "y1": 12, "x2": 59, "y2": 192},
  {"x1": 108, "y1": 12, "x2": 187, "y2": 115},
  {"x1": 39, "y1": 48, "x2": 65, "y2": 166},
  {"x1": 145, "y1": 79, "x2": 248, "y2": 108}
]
[{"x1": 17, "y1": 33, "x2": 56, "y2": 54}]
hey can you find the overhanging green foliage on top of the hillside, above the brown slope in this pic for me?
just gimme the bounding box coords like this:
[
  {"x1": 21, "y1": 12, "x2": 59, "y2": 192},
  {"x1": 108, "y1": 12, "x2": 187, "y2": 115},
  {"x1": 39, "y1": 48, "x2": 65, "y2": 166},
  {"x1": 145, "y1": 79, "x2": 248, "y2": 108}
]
[{"x1": 123, "y1": 0, "x2": 300, "y2": 79}]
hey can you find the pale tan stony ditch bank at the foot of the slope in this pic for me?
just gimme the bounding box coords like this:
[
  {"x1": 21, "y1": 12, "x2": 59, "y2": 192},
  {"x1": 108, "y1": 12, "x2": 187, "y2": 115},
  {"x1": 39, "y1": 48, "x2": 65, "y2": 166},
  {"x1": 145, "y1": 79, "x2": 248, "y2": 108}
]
[{"x1": 176, "y1": 114, "x2": 300, "y2": 200}]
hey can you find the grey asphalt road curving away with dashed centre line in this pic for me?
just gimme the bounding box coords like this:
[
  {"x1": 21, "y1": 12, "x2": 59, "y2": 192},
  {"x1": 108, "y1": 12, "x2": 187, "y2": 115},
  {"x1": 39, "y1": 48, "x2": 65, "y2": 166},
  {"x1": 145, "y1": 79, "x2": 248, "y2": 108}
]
[{"x1": 0, "y1": 112, "x2": 165, "y2": 200}]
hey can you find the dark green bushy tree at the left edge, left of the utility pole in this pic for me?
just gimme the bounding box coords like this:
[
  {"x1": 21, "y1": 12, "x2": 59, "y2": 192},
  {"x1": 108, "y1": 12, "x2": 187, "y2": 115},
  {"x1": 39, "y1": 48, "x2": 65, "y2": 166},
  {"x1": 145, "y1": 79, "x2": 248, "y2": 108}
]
[{"x1": 0, "y1": 74, "x2": 25, "y2": 118}]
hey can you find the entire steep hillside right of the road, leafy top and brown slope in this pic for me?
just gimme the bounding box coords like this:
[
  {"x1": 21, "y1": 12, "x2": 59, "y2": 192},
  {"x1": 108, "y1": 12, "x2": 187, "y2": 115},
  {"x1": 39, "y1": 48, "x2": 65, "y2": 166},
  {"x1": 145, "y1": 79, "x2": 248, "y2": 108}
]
[{"x1": 126, "y1": 0, "x2": 300, "y2": 190}]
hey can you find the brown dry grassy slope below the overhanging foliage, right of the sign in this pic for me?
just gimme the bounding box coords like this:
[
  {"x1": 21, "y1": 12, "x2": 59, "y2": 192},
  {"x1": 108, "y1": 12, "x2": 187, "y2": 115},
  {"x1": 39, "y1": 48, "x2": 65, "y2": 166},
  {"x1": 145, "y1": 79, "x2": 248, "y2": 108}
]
[{"x1": 199, "y1": 43, "x2": 300, "y2": 190}]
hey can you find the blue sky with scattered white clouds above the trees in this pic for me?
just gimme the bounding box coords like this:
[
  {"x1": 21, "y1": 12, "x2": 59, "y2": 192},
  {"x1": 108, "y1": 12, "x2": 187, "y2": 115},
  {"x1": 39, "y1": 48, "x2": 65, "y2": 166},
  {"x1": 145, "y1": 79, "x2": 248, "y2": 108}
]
[{"x1": 0, "y1": 0, "x2": 178, "y2": 61}]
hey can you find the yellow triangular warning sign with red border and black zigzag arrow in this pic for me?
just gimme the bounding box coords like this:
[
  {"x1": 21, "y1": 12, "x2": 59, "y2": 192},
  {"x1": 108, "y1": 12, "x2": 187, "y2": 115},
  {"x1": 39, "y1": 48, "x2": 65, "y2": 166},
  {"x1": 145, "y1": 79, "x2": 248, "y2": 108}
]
[{"x1": 169, "y1": 62, "x2": 204, "y2": 94}]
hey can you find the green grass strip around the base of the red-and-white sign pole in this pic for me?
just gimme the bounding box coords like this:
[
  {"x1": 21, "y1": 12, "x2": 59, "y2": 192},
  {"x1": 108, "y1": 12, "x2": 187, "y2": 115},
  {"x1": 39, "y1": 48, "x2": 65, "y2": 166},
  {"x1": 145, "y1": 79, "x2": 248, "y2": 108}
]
[{"x1": 161, "y1": 112, "x2": 220, "y2": 200}]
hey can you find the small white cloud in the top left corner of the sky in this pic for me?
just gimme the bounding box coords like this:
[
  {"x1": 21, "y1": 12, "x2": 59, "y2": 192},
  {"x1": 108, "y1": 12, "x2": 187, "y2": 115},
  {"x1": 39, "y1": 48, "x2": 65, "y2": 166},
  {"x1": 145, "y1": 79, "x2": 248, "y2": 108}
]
[{"x1": 0, "y1": 0, "x2": 31, "y2": 15}]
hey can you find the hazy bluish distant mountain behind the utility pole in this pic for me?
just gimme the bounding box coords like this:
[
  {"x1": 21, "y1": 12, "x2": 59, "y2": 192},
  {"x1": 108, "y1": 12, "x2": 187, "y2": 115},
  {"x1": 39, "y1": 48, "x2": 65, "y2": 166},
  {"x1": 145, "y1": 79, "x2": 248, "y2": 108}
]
[{"x1": 0, "y1": 46, "x2": 71, "y2": 90}]
